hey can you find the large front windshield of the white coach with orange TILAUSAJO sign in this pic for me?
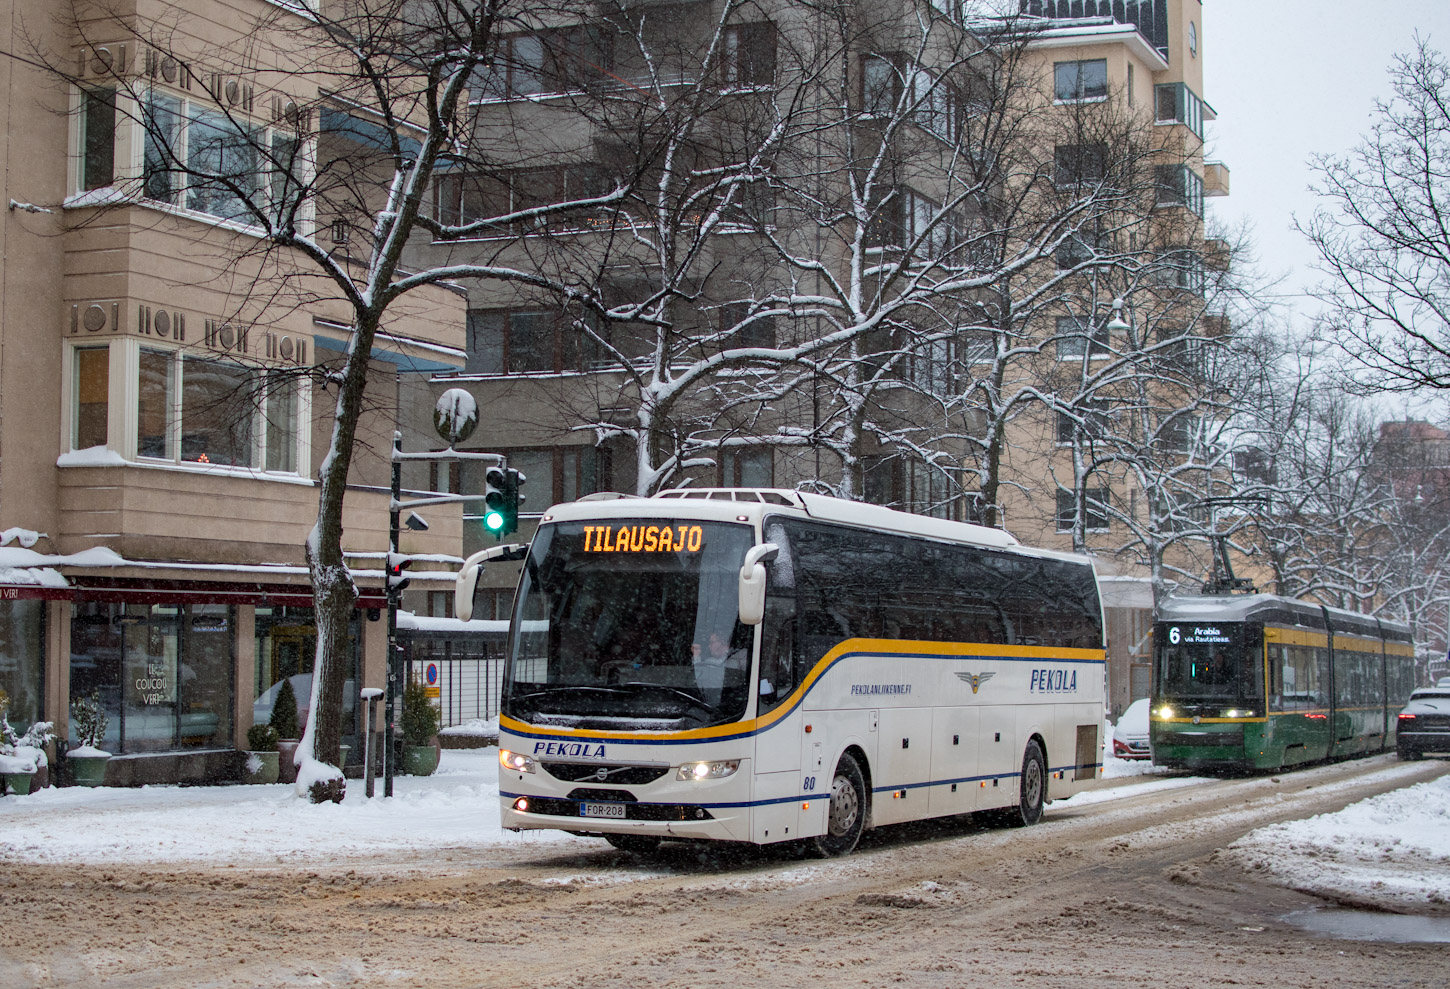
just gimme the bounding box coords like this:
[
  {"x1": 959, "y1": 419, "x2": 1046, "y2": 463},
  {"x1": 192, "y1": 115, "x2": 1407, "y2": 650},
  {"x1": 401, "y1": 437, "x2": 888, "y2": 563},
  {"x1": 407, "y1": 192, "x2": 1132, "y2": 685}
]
[{"x1": 502, "y1": 519, "x2": 754, "y2": 731}]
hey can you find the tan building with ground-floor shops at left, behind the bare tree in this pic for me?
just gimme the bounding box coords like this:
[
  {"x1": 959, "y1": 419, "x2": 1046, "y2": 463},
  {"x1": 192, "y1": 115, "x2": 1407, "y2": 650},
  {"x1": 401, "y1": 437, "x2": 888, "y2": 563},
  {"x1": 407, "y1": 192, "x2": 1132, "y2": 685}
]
[{"x1": 0, "y1": 0, "x2": 464, "y2": 785}]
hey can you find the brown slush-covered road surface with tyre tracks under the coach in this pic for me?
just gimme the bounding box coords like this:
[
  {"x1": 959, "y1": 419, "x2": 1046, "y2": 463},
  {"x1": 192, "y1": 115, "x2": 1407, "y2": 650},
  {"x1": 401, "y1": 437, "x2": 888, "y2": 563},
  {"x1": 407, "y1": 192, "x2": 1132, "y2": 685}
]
[{"x1": 0, "y1": 756, "x2": 1450, "y2": 989}]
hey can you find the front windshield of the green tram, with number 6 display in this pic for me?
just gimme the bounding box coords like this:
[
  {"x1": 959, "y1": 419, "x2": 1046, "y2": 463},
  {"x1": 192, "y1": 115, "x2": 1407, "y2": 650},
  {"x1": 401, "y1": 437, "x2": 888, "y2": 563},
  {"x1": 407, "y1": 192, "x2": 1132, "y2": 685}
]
[{"x1": 1153, "y1": 622, "x2": 1264, "y2": 704}]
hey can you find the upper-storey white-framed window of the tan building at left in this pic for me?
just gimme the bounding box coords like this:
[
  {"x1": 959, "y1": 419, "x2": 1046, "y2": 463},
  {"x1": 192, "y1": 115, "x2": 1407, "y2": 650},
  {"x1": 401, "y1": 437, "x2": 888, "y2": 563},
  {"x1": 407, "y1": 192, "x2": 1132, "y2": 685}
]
[{"x1": 142, "y1": 90, "x2": 305, "y2": 226}]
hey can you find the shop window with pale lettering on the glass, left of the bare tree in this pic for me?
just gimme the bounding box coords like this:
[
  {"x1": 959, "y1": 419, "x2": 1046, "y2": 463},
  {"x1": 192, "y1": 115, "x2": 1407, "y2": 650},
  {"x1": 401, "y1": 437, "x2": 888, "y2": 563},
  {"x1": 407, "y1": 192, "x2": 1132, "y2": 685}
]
[{"x1": 70, "y1": 600, "x2": 235, "y2": 754}]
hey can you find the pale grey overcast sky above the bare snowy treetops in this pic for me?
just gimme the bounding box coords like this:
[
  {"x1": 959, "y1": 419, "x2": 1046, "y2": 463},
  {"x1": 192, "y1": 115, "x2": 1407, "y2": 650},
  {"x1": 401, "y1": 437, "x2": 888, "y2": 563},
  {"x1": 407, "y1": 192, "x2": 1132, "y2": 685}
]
[{"x1": 1202, "y1": 0, "x2": 1450, "y2": 310}]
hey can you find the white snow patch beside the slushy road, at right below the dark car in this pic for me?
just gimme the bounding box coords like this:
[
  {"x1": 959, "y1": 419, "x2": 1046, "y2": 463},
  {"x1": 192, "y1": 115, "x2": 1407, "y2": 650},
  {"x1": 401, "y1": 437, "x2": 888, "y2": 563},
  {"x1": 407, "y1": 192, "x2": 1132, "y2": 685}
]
[{"x1": 1227, "y1": 759, "x2": 1450, "y2": 911}]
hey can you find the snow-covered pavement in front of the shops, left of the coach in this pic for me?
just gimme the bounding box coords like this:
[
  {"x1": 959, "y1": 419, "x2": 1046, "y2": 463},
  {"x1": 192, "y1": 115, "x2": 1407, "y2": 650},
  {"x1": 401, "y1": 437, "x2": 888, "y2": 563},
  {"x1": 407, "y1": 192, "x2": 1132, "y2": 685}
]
[{"x1": 0, "y1": 748, "x2": 588, "y2": 866}]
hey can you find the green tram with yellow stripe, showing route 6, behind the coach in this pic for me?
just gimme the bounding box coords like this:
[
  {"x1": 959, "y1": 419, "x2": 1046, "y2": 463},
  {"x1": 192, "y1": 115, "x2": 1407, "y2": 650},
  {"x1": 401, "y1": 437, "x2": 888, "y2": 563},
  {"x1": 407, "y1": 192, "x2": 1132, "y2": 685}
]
[{"x1": 1148, "y1": 595, "x2": 1415, "y2": 770}]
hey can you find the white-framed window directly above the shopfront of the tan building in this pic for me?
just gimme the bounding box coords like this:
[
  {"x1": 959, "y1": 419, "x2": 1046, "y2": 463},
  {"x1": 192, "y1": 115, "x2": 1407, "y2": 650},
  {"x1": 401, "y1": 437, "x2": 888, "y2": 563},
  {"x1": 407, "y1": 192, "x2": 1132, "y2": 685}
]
[{"x1": 136, "y1": 348, "x2": 307, "y2": 474}]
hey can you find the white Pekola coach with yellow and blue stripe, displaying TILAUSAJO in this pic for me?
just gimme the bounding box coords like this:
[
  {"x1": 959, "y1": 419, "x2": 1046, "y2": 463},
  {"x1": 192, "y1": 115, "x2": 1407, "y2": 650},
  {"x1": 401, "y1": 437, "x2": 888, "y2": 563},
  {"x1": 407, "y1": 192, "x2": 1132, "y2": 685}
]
[{"x1": 457, "y1": 489, "x2": 1105, "y2": 854}]
